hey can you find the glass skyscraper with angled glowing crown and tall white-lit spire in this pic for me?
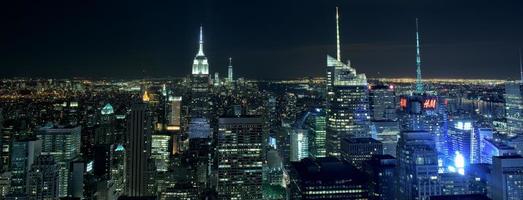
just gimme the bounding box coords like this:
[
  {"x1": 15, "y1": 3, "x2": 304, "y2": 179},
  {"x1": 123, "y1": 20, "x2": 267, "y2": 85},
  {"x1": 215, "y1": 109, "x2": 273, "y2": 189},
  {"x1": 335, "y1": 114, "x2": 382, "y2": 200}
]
[{"x1": 326, "y1": 8, "x2": 370, "y2": 156}]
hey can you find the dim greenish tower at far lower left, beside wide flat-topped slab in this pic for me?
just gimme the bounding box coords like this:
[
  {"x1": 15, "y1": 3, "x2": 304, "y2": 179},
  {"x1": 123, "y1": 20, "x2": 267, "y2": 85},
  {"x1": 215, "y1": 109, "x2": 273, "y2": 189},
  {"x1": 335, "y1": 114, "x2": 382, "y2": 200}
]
[{"x1": 10, "y1": 138, "x2": 42, "y2": 195}]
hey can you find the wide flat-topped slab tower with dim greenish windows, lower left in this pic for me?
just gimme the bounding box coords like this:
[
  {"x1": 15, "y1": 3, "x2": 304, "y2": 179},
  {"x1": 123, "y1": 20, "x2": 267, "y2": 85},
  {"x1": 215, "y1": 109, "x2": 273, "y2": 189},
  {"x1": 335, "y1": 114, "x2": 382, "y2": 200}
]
[{"x1": 37, "y1": 126, "x2": 81, "y2": 197}]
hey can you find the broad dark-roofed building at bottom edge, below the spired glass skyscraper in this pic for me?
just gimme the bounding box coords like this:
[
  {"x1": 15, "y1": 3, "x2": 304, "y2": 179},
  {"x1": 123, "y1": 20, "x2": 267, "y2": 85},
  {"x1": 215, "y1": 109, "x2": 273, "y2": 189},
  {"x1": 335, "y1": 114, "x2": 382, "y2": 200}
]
[{"x1": 289, "y1": 157, "x2": 368, "y2": 199}]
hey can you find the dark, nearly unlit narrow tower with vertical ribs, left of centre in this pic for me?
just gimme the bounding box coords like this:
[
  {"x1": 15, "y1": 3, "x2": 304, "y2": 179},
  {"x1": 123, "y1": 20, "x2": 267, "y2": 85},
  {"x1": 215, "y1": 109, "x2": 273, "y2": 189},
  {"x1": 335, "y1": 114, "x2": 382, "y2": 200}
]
[{"x1": 126, "y1": 104, "x2": 151, "y2": 197}]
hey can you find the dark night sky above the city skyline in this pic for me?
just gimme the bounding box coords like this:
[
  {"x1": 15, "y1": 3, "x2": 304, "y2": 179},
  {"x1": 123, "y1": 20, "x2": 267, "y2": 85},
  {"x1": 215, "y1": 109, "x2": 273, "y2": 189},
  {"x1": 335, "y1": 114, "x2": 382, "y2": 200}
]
[{"x1": 0, "y1": 0, "x2": 523, "y2": 79}]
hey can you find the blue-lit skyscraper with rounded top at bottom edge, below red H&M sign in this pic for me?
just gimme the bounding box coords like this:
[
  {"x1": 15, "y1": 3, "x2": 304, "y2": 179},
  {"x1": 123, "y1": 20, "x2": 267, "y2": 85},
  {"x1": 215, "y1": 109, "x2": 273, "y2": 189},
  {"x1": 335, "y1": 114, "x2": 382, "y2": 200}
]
[{"x1": 397, "y1": 131, "x2": 441, "y2": 200}]
